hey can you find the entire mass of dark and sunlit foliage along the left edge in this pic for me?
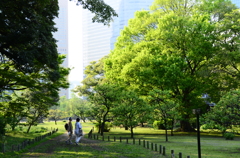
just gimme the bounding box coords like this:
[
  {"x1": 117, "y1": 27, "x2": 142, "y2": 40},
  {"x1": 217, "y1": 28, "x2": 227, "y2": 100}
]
[{"x1": 0, "y1": 0, "x2": 69, "y2": 134}]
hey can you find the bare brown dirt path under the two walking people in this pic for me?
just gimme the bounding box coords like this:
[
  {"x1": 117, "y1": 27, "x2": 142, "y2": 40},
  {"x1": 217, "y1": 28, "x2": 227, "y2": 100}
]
[{"x1": 21, "y1": 133, "x2": 104, "y2": 158}]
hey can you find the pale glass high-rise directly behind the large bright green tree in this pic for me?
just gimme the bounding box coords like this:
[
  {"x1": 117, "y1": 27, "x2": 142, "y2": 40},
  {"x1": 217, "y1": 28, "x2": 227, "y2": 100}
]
[{"x1": 82, "y1": 0, "x2": 154, "y2": 73}]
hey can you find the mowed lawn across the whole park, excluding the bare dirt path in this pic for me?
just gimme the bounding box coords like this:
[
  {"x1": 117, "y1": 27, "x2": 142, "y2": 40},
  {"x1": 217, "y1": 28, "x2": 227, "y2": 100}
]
[{"x1": 0, "y1": 121, "x2": 240, "y2": 158}]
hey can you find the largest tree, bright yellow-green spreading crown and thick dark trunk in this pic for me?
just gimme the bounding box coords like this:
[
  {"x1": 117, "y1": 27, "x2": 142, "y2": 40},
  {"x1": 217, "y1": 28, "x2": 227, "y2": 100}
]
[{"x1": 104, "y1": 0, "x2": 240, "y2": 131}]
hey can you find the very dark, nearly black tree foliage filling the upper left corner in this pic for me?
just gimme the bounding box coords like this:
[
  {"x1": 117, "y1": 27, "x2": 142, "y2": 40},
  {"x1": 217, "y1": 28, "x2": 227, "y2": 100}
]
[{"x1": 0, "y1": 0, "x2": 58, "y2": 74}]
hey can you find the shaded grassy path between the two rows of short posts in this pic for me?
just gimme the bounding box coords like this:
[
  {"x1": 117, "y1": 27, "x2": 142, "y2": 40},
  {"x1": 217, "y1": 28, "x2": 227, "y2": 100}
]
[{"x1": 16, "y1": 133, "x2": 162, "y2": 158}]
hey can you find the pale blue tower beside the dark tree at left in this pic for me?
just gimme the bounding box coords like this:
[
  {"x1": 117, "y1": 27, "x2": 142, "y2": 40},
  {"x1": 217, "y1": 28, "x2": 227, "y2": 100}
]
[{"x1": 54, "y1": 0, "x2": 69, "y2": 98}]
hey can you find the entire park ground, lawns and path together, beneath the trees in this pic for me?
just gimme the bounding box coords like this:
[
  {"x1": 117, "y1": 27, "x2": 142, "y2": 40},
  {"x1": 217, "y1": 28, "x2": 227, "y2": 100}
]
[{"x1": 0, "y1": 121, "x2": 240, "y2": 158}]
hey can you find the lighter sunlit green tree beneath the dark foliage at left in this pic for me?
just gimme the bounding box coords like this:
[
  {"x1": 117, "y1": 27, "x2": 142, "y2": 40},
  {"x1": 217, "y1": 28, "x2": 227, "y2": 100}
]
[{"x1": 0, "y1": 56, "x2": 69, "y2": 133}]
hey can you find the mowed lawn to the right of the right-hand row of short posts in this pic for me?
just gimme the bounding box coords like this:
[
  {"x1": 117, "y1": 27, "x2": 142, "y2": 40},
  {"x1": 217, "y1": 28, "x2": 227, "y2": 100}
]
[{"x1": 90, "y1": 127, "x2": 240, "y2": 158}]
